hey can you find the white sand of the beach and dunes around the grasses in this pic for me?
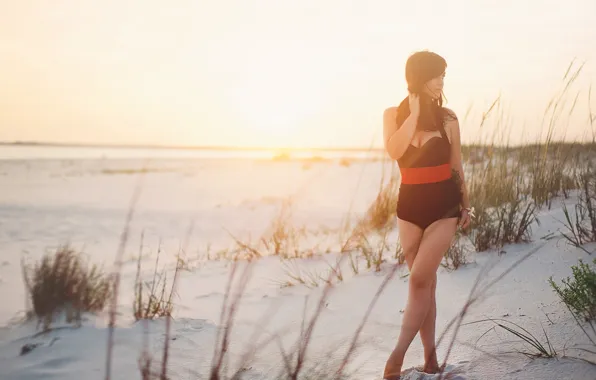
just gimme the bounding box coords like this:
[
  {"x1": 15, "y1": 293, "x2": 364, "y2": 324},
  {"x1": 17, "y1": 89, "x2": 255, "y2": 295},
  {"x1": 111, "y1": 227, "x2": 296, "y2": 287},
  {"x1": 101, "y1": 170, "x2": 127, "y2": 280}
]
[{"x1": 0, "y1": 155, "x2": 596, "y2": 380}]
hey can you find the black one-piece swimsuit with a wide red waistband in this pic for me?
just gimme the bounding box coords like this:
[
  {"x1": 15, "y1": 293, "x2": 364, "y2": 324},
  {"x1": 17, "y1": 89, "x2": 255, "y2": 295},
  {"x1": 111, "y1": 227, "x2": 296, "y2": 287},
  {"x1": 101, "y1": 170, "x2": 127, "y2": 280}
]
[{"x1": 397, "y1": 120, "x2": 462, "y2": 230}]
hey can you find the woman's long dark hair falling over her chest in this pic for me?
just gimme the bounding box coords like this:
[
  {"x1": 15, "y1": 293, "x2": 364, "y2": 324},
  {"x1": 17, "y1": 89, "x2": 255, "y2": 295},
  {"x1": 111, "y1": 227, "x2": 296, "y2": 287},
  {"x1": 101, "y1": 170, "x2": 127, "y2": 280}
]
[{"x1": 397, "y1": 51, "x2": 449, "y2": 131}]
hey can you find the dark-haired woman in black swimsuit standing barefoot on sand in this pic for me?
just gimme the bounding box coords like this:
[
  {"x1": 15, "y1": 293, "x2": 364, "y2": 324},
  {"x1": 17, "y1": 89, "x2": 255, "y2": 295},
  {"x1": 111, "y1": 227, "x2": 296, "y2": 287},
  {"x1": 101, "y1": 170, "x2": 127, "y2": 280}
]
[{"x1": 383, "y1": 51, "x2": 472, "y2": 380}]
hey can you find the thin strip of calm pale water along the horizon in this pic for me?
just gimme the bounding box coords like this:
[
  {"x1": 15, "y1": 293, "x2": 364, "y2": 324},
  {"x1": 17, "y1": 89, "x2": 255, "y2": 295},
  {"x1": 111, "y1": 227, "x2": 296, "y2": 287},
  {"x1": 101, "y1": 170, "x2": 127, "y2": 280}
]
[{"x1": 0, "y1": 145, "x2": 381, "y2": 160}]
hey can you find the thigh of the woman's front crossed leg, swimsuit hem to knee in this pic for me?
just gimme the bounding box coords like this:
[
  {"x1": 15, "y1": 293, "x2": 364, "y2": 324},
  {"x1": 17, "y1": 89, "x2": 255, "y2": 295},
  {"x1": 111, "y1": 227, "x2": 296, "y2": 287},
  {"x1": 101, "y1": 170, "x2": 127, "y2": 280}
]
[{"x1": 410, "y1": 218, "x2": 457, "y2": 279}]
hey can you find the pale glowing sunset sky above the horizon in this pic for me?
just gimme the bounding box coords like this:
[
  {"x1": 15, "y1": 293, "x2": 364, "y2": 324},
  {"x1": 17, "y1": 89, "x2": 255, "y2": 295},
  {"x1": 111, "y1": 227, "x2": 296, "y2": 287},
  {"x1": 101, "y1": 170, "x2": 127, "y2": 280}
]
[{"x1": 0, "y1": 0, "x2": 596, "y2": 147}]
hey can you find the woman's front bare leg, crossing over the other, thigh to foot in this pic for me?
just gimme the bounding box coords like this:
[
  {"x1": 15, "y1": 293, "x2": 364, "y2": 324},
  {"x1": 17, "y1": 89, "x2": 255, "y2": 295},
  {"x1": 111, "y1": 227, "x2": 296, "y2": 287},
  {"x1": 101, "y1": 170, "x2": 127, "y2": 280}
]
[{"x1": 384, "y1": 218, "x2": 457, "y2": 378}]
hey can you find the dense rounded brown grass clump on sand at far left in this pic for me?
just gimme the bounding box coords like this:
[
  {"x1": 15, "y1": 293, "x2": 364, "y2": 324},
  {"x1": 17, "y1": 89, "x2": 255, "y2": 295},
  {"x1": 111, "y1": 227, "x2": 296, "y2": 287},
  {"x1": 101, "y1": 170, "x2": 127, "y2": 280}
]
[{"x1": 22, "y1": 245, "x2": 112, "y2": 330}]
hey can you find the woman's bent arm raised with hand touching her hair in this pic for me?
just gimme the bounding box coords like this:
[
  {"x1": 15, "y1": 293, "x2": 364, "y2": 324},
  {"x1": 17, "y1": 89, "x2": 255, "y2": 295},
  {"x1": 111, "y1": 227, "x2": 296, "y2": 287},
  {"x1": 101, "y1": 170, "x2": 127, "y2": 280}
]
[{"x1": 383, "y1": 95, "x2": 420, "y2": 160}]
